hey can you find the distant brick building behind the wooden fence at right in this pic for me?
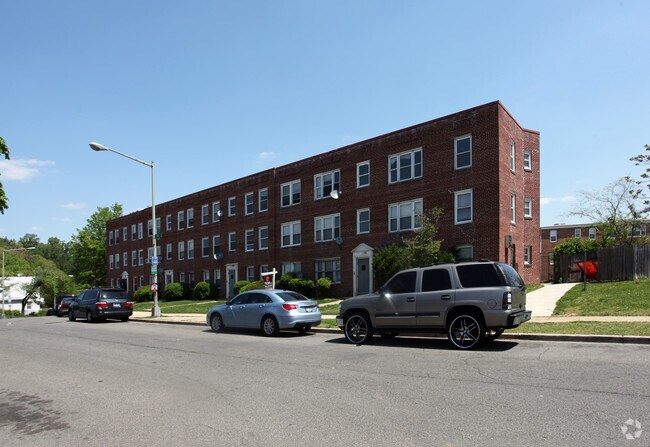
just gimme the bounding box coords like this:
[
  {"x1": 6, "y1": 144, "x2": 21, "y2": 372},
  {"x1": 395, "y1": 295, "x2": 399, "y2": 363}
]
[{"x1": 540, "y1": 222, "x2": 650, "y2": 281}]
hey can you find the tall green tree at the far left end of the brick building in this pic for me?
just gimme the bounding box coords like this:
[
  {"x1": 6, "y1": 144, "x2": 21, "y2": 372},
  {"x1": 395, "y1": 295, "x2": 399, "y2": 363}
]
[{"x1": 70, "y1": 203, "x2": 122, "y2": 287}]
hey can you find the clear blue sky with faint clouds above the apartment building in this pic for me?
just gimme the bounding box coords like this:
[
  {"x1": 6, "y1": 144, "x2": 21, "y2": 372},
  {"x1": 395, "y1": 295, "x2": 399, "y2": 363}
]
[{"x1": 0, "y1": 0, "x2": 650, "y2": 242}]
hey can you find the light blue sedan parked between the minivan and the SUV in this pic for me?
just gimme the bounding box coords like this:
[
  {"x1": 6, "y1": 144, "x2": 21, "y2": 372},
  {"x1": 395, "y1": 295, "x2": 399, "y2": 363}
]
[{"x1": 206, "y1": 290, "x2": 321, "y2": 336}]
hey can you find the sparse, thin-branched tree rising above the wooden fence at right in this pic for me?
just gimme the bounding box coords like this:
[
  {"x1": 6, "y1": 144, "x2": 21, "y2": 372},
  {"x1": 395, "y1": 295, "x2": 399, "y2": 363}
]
[{"x1": 569, "y1": 177, "x2": 647, "y2": 246}]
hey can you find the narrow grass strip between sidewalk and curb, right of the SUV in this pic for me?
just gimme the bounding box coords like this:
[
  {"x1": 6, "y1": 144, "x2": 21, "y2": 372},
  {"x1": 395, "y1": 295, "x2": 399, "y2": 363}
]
[{"x1": 506, "y1": 321, "x2": 650, "y2": 336}]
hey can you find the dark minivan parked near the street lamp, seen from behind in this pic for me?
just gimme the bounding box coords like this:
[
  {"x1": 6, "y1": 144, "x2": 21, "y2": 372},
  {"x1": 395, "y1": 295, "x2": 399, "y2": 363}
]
[{"x1": 68, "y1": 287, "x2": 133, "y2": 323}]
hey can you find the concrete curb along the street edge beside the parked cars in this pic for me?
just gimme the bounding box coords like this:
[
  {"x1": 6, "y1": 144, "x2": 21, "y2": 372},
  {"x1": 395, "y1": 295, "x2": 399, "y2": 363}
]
[{"x1": 131, "y1": 317, "x2": 650, "y2": 345}]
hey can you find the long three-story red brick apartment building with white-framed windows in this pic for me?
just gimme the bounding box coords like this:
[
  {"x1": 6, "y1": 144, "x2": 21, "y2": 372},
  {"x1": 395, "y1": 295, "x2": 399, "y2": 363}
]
[{"x1": 107, "y1": 101, "x2": 540, "y2": 297}]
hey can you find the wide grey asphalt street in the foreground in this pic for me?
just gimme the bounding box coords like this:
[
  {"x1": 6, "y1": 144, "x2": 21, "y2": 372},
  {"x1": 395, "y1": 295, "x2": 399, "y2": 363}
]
[{"x1": 0, "y1": 318, "x2": 650, "y2": 447}]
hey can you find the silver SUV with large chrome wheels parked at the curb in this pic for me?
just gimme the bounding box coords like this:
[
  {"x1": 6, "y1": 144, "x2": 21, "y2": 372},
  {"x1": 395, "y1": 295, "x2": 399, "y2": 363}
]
[{"x1": 336, "y1": 261, "x2": 531, "y2": 349}]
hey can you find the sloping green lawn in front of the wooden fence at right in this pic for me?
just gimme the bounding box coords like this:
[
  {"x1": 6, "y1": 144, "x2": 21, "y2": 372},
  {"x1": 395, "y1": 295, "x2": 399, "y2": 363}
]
[{"x1": 553, "y1": 279, "x2": 650, "y2": 316}]
